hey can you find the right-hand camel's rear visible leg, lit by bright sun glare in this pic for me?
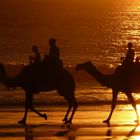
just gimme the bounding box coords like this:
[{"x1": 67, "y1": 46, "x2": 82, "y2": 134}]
[{"x1": 125, "y1": 93, "x2": 139, "y2": 123}]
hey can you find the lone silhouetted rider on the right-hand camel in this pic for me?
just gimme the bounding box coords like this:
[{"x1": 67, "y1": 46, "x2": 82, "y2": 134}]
[{"x1": 122, "y1": 42, "x2": 135, "y2": 64}]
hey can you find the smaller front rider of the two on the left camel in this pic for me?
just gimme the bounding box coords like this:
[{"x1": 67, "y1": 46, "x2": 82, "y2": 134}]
[{"x1": 29, "y1": 45, "x2": 41, "y2": 64}]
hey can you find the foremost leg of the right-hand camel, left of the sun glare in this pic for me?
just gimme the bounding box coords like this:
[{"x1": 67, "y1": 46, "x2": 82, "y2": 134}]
[{"x1": 103, "y1": 91, "x2": 118, "y2": 123}]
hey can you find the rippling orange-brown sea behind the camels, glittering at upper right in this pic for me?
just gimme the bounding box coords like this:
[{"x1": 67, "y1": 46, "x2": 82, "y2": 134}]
[{"x1": 0, "y1": 0, "x2": 140, "y2": 104}]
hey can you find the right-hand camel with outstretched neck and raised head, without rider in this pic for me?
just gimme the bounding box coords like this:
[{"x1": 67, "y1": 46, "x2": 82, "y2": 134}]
[{"x1": 76, "y1": 61, "x2": 140, "y2": 123}]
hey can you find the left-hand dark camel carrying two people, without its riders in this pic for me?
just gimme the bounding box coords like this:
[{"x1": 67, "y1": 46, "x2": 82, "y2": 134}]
[{"x1": 0, "y1": 63, "x2": 78, "y2": 124}]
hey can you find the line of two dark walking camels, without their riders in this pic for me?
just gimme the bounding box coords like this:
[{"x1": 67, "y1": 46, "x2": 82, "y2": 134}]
[{"x1": 0, "y1": 61, "x2": 140, "y2": 124}]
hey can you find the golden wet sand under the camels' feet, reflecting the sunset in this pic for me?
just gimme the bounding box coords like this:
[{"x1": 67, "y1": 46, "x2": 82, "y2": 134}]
[{"x1": 0, "y1": 105, "x2": 140, "y2": 140}]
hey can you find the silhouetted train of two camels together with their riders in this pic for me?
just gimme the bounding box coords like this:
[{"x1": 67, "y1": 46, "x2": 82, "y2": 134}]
[{"x1": 0, "y1": 39, "x2": 140, "y2": 124}]
